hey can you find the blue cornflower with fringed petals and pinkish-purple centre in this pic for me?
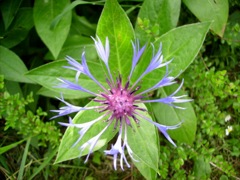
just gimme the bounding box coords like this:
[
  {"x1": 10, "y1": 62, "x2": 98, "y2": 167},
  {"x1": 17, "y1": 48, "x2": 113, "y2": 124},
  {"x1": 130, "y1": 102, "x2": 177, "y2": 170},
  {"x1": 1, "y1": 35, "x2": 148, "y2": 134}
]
[{"x1": 53, "y1": 37, "x2": 191, "y2": 170}]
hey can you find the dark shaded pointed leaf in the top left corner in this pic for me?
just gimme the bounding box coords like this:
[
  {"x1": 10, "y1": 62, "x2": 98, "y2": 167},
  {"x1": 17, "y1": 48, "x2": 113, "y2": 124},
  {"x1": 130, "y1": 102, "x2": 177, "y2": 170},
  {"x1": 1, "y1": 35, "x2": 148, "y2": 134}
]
[{"x1": 0, "y1": 0, "x2": 22, "y2": 30}]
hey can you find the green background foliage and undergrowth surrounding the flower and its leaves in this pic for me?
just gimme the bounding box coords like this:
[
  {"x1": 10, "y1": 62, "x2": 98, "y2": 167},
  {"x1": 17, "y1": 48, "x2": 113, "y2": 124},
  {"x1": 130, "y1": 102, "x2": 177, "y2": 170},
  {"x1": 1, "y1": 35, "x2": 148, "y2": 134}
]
[{"x1": 0, "y1": 0, "x2": 240, "y2": 180}]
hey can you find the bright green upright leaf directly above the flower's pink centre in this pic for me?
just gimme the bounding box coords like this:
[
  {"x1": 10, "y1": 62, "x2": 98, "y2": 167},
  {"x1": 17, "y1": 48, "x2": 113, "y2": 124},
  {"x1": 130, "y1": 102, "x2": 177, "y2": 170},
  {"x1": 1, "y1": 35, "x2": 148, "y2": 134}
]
[{"x1": 97, "y1": 0, "x2": 134, "y2": 80}]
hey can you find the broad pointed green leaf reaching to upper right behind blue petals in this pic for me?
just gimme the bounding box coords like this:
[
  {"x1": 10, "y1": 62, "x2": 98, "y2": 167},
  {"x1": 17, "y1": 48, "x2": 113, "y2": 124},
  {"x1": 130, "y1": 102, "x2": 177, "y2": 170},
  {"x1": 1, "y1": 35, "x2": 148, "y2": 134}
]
[{"x1": 133, "y1": 22, "x2": 210, "y2": 91}]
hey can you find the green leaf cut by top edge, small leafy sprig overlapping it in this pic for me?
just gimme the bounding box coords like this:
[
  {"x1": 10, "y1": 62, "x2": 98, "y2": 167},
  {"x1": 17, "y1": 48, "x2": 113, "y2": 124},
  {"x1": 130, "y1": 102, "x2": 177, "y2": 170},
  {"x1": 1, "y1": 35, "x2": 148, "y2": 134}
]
[{"x1": 135, "y1": 0, "x2": 181, "y2": 43}]
